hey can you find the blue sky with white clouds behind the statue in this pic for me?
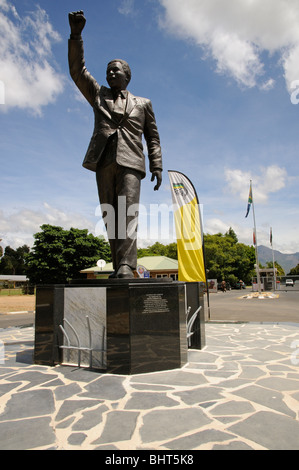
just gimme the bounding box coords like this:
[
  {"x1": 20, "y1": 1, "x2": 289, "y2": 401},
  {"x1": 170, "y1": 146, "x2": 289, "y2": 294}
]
[{"x1": 0, "y1": 0, "x2": 299, "y2": 258}]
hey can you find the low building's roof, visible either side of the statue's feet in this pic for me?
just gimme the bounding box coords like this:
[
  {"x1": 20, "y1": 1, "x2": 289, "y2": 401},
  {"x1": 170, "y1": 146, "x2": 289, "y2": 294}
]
[{"x1": 80, "y1": 256, "x2": 178, "y2": 274}]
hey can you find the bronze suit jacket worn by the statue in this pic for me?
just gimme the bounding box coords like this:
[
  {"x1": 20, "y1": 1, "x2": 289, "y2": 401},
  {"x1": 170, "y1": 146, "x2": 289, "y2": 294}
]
[{"x1": 68, "y1": 39, "x2": 162, "y2": 178}]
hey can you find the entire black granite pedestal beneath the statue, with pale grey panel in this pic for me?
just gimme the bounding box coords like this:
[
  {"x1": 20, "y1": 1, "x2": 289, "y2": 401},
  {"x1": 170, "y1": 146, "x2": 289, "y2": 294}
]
[{"x1": 34, "y1": 279, "x2": 204, "y2": 374}]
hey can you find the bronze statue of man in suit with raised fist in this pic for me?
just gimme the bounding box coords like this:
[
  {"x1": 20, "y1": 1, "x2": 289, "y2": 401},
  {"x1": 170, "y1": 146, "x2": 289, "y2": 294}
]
[{"x1": 68, "y1": 11, "x2": 162, "y2": 278}]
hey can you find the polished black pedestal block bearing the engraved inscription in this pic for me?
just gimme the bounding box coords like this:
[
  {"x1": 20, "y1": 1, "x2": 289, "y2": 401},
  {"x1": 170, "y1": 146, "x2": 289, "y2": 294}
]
[{"x1": 107, "y1": 282, "x2": 188, "y2": 374}]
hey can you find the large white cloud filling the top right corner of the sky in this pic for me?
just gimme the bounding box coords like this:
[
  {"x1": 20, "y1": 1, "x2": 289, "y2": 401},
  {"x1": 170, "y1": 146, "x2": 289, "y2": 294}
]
[{"x1": 160, "y1": 0, "x2": 299, "y2": 91}]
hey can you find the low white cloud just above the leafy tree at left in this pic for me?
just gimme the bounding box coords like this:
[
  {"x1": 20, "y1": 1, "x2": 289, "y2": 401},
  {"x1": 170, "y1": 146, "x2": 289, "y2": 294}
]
[{"x1": 0, "y1": 203, "x2": 95, "y2": 248}]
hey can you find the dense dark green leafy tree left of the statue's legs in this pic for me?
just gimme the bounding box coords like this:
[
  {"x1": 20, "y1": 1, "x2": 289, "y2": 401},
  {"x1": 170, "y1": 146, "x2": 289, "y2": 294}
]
[{"x1": 26, "y1": 225, "x2": 111, "y2": 284}]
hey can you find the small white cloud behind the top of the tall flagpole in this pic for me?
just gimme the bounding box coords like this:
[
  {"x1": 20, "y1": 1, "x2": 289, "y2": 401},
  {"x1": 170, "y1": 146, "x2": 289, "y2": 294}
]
[{"x1": 225, "y1": 165, "x2": 287, "y2": 203}]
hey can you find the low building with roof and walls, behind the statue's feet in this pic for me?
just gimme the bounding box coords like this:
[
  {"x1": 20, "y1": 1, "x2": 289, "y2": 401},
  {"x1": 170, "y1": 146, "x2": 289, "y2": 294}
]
[{"x1": 80, "y1": 256, "x2": 178, "y2": 281}]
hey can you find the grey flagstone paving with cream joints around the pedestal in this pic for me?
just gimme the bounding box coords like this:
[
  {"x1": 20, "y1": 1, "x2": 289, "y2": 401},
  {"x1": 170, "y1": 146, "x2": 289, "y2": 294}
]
[{"x1": 0, "y1": 323, "x2": 299, "y2": 455}]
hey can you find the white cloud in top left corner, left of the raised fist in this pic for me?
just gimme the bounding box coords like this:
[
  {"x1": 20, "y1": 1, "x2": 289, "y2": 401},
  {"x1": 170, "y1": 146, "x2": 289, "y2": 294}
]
[{"x1": 0, "y1": 0, "x2": 64, "y2": 114}]
